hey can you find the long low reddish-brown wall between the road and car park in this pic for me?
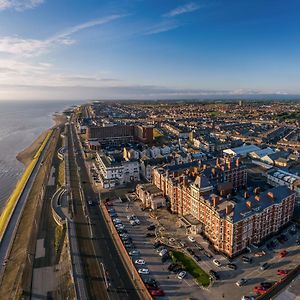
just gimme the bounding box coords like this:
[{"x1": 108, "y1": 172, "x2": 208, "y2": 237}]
[{"x1": 100, "y1": 202, "x2": 152, "y2": 300}]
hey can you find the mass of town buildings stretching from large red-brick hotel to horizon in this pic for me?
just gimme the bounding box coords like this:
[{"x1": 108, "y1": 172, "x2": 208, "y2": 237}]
[{"x1": 77, "y1": 101, "x2": 300, "y2": 257}]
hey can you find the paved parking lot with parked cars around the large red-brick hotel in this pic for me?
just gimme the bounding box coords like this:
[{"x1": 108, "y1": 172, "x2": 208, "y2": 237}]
[{"x1": 104, "y1": 195, "x2": 300, "y2": 299}]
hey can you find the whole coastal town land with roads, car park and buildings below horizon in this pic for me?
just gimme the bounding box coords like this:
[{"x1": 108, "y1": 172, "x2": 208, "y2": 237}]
[{"x1": 0, "y1": 100, "x2": 300, "y2": 300}]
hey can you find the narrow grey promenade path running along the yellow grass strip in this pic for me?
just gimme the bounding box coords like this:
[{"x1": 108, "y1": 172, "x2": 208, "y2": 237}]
[{"x1": 0, "y1": 129, "x2": 56, "y2": 283}]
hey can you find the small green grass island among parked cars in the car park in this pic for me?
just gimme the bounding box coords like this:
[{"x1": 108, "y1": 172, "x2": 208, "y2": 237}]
[{"x1": 170, "y1": 251, "x2": 210, "y2": 287}]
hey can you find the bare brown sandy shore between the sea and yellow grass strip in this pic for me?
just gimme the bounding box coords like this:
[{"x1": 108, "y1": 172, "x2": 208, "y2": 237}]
[{"x1": 16, "y1": 113, "x2": 66, "y2": 167}]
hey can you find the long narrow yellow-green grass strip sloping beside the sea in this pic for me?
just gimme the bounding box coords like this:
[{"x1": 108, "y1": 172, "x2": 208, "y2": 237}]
[{"x1": 0, "y1": 130, "x2": 52, "y2": 237}]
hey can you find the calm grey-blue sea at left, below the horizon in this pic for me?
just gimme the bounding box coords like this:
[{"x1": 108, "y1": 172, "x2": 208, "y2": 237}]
[{"x1": 0, "y1": 101, "x2": 79, "y2": 212}]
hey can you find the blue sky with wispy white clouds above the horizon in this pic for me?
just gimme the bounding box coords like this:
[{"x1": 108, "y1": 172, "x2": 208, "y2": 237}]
[{"x1": 0, "y1": 0, "x2": 300, "y2": 100}]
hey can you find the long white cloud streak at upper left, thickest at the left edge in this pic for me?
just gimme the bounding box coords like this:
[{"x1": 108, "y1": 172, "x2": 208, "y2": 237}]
[{"x1": 0, "y1": 14, "x2": 125, "y2": 56}]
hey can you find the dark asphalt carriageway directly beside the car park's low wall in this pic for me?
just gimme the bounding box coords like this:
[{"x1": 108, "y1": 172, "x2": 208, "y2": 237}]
[{"x1": 71, "y1": 120, "x2": 140, "y2": 300}]
